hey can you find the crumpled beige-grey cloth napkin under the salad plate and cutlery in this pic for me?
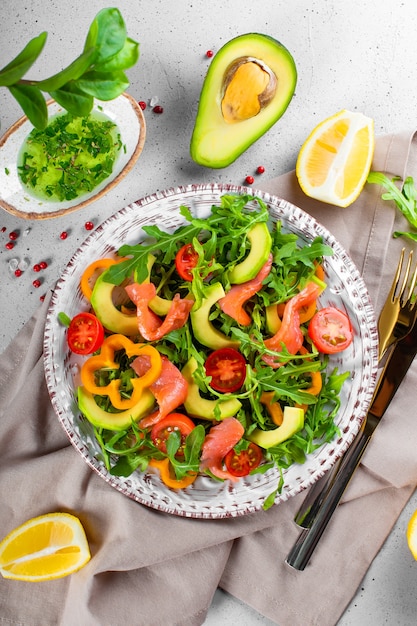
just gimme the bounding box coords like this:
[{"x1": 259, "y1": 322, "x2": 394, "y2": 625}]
[{"x1": 0, "y1": 128, "x2": 417, "y2": 626}]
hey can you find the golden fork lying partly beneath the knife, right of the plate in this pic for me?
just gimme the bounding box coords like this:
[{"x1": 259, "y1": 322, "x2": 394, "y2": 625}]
[{"x1": 294, "y1": 248, "x2": 417, "y2": 528}]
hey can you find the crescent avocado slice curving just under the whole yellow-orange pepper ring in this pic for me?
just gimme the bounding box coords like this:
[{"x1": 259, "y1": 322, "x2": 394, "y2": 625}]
[{"x1": 77, "y1": 386, "x2": 155, "y2": 430}]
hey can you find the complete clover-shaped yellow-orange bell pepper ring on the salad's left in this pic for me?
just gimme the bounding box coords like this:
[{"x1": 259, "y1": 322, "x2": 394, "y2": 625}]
[{"x1": 80, "y1": 334, "x2": 162, "y2": 411}]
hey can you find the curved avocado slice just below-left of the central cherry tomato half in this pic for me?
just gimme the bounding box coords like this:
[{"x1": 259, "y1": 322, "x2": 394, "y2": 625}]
[{"x1": 181, "y1": 357, "x2": 242, "y2": 420}]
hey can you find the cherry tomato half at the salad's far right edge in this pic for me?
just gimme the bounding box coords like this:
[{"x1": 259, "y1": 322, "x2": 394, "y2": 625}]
[{"x1": 308, "y1": 307, "x2": 353, "y2": 354}]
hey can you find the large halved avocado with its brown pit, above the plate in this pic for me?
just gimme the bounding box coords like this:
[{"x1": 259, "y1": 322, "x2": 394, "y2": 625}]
[{"x1": 190, "y1": 33, "x2": 297, "y2": 168}]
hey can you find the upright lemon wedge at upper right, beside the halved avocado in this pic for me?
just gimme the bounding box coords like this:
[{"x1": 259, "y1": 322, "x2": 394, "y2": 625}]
[{"x1": 295, "y1": 110, "x2": 375, "y2": 207}]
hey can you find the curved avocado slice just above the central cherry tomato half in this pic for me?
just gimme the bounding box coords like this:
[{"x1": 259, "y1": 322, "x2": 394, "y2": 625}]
[{"x1": 190, "y1": 283, "x2": 239, "y2": 350}]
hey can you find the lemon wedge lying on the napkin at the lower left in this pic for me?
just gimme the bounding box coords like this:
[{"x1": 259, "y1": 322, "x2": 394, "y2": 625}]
[{"x1": 0, "y1": 513, "x2": 91, "y2": 582}]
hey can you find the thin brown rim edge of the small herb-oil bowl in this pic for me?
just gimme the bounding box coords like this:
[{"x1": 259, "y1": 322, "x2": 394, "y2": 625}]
[{"x1": 0, "y1": 92, "x2": 146, "y2": 220}]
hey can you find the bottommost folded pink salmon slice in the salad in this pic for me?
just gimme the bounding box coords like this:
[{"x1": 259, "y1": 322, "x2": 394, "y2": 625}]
[{"x1": 200, "y1": 417, "x2": 245, "y2": 482}]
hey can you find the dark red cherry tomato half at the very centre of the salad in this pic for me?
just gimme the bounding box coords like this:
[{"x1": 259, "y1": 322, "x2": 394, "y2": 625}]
[{"x1": 204, "y1": 348, "x2": 246, "y2": 393}]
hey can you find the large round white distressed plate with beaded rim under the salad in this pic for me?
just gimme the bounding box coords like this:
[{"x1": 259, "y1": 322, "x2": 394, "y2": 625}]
[{"x1": 44, "y1": 184, "x2": 378, "y2": 519}]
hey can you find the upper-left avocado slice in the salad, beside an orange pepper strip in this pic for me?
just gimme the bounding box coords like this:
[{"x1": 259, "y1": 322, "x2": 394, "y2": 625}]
[{"x1": 90, "y1": 272, "x2": 139, "y2": 337}]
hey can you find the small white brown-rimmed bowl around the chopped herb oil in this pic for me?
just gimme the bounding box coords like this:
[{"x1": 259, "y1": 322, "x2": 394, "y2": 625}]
[{"x1": 0, "y1": 93, "x2": 146, "y2": 219}]
